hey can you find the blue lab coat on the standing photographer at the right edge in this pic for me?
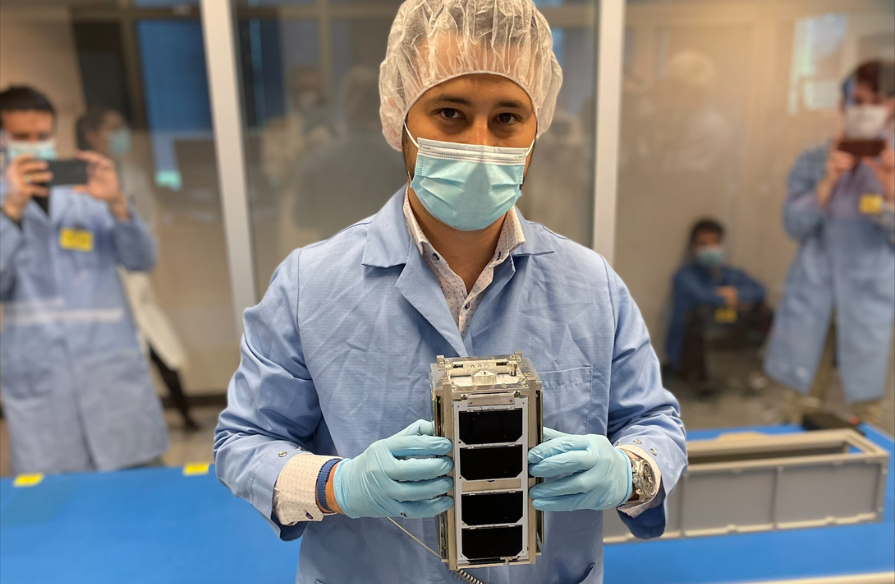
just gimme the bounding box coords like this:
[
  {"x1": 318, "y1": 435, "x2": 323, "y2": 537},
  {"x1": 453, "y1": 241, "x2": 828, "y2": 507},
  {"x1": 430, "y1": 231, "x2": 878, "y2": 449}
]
[{"x1": 765, "y1": 145, "x2": 895, "y2": 402}]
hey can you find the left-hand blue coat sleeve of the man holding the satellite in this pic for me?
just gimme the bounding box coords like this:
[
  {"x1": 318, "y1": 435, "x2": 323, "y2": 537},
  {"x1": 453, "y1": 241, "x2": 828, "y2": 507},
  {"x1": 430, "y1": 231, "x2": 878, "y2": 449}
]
[{"x1": 214, "y1": 250, "x2": 322, "y2": 540}]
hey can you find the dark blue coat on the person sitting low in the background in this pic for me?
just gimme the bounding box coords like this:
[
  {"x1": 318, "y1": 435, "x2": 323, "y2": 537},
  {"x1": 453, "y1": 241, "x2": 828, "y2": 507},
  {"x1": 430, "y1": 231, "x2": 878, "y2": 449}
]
[{"x1": 665, "y1": 263, "x2": 765, "y2": 367}]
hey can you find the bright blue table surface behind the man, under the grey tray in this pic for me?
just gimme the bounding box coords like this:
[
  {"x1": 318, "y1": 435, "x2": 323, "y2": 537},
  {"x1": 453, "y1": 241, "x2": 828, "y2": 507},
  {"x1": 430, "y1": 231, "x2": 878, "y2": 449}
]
[{"x1": 0, "y1": 427, "x2": 895, "y2": 584}]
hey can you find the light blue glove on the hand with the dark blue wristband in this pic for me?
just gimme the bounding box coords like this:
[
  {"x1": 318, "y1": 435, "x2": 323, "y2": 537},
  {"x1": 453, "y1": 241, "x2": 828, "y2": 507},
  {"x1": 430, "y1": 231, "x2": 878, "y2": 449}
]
[{"x1": 333, "y1": 420, "x2": 454, "y2": 519}]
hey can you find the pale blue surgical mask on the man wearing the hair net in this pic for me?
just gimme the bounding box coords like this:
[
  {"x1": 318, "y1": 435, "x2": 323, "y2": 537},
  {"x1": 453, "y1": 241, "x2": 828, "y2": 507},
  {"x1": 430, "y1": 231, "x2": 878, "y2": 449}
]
[{"x1": 404, "y1": 124, "x2": 534, "y2": 231}]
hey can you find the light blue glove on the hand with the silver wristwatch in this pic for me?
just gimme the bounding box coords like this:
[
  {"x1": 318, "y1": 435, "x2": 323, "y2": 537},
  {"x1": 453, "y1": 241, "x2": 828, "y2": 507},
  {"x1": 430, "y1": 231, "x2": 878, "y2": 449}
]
[{"x1": 528, "y1": 428, "x2": 633, "y2": 511}]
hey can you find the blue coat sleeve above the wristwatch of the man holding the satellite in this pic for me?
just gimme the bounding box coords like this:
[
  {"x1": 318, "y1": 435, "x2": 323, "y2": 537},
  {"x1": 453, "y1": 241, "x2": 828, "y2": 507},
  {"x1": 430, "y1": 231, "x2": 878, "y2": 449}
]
[{"x1": 604, "y1": 262, "x2": 687, "y2": 539}]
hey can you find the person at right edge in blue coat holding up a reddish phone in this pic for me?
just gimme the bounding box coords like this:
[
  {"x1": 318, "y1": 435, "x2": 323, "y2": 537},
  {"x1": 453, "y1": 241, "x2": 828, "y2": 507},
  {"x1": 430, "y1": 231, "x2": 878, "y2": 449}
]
[{"x1": 765, "y1": 60, "x2": 895, "y2": 424}]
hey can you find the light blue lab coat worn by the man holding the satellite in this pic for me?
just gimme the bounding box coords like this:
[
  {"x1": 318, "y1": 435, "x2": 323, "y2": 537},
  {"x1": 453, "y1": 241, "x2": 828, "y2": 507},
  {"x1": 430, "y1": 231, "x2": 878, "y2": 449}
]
[{"x1": 215, "y1": 189, "x2": 687, "y2": 584}]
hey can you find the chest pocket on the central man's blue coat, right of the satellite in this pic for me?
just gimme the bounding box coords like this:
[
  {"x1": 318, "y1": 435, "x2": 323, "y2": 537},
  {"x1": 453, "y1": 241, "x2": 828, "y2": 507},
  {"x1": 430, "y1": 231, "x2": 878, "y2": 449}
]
[{"x1": 538, "y1": 367, "x2": 593, "y2": 434}]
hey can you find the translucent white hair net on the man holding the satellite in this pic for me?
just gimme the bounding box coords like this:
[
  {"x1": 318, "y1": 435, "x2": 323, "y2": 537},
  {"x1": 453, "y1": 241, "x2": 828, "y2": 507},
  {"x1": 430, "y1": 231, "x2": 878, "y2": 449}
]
[{"x1": 379, "y1": 0, "x2": 562, "y2": 150}]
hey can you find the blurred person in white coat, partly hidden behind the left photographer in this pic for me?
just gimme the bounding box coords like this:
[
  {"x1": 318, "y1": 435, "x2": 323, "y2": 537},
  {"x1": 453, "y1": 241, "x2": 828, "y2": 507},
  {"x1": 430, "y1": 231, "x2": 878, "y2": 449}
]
[{"x1": 75, "y1": 107, "x2": 199, "y2": 432}]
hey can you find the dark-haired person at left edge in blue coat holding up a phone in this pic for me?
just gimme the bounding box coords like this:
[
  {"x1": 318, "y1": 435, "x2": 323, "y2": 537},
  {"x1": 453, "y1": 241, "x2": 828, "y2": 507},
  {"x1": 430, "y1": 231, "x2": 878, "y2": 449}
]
[{"x1": 0, "y1": 86, "x2": 168, "y2": 473}]
